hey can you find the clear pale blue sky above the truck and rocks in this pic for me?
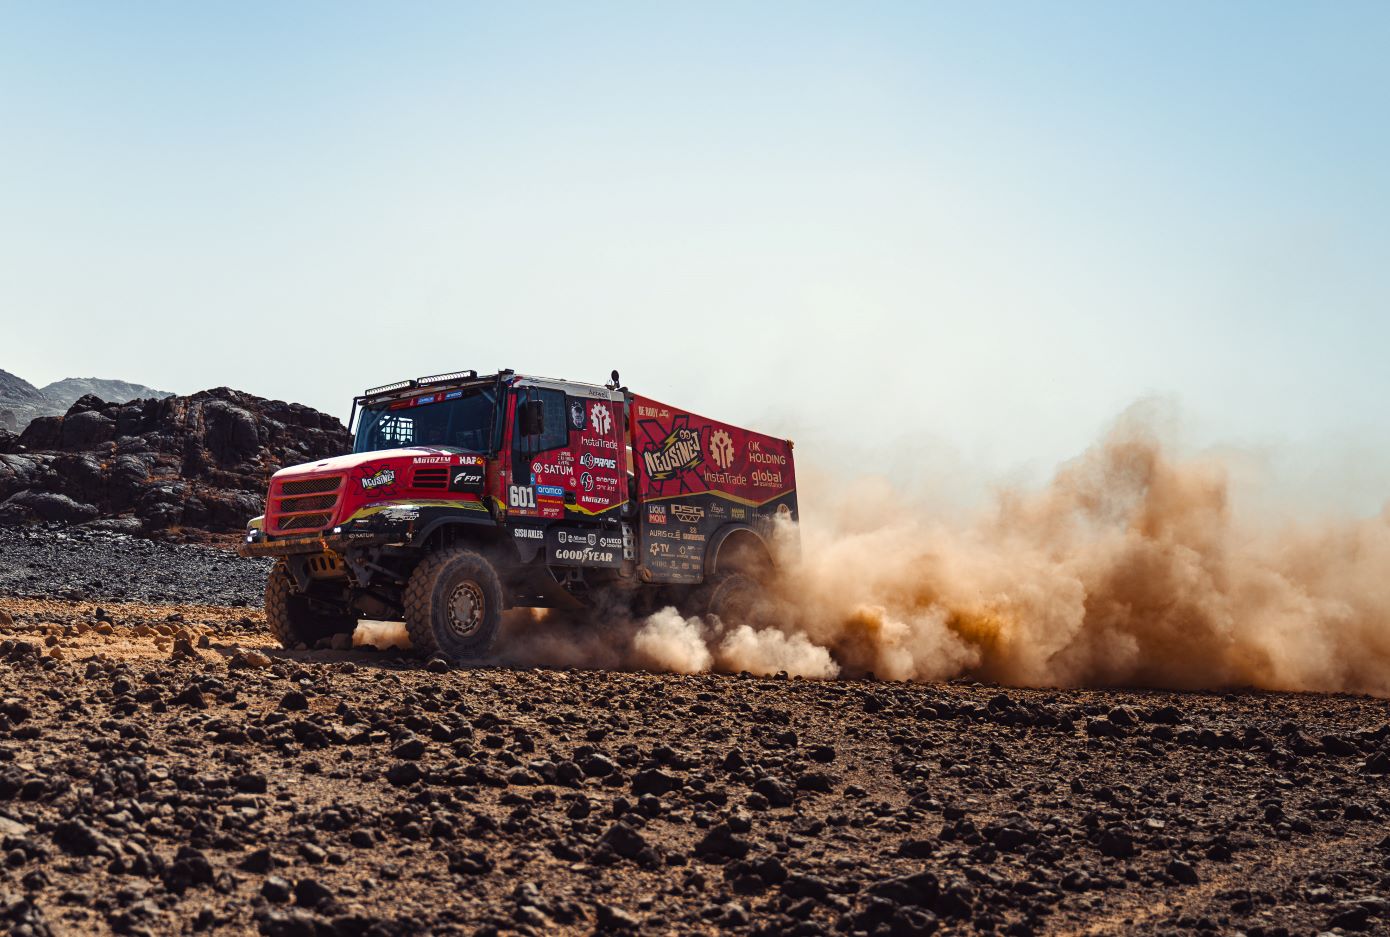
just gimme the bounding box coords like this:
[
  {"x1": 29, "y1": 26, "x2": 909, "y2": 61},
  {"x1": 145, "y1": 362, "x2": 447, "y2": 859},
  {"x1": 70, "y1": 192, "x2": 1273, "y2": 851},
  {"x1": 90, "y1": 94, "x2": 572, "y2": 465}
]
[{"x1": 0, "y1": 1, "x2": 1390, "y2": 509}]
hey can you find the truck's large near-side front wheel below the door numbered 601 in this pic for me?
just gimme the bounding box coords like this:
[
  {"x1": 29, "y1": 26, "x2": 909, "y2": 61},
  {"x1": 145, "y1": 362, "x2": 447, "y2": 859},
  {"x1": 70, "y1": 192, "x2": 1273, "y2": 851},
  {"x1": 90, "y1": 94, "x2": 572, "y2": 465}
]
[{"x1": 406, "y1": 546, "x2": 502, "y2": 660}]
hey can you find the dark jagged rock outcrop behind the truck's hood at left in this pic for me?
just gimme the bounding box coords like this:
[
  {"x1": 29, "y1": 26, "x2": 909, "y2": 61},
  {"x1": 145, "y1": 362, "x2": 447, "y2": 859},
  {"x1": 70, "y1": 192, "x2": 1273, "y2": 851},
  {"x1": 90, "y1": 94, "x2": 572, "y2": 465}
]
[{"x1": 0, "y1": 388, "x2": 352, "y2": 538}]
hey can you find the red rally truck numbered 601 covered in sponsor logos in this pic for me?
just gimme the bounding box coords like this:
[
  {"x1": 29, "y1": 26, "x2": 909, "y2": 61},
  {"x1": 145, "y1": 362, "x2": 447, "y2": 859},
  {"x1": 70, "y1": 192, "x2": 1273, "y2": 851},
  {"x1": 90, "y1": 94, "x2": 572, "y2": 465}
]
[{"x1": 239, "y1": 370, "x2": 798, "y2": 660}]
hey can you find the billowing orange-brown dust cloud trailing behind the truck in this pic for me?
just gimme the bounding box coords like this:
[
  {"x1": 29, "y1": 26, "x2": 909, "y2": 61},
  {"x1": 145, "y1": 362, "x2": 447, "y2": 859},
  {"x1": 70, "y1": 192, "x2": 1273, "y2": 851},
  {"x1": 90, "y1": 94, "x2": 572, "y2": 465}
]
[{"x1": 503, "y1": 414, "x2": 1390, "y2": 696}]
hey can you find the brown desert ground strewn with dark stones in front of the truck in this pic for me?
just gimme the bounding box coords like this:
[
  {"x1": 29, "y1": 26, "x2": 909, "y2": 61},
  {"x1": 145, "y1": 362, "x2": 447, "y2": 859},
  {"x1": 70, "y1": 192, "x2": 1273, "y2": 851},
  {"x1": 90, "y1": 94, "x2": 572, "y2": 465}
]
[{"x1": 0, "y1": 532, "x2": 1390, "y2": 937}]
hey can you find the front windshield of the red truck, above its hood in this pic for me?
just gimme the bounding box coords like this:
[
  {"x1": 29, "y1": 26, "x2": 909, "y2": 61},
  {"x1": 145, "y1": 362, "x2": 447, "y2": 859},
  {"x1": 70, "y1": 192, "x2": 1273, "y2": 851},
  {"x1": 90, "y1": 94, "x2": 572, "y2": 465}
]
[{"x1": 353, "y1": 386, "x2": 502, "y2": 452}]
